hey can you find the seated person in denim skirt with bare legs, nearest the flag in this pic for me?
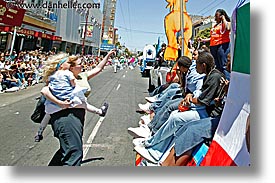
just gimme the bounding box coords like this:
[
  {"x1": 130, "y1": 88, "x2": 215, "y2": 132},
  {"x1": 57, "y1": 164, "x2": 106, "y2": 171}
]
[{"x1": 161, "y1": 79, "x2": 229, "y2": 166}]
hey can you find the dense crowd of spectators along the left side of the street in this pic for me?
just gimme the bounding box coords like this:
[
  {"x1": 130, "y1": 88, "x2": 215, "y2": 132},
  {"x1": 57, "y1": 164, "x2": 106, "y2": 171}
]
[{"x1": 0, "y1": 48, "x2": 102, "y2": 93}]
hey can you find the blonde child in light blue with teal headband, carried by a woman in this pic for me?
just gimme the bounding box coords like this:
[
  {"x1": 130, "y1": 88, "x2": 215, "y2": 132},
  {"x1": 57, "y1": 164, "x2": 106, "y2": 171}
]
[{"x1": 35, "y1": 53, "x2": 108, "y2": 142}]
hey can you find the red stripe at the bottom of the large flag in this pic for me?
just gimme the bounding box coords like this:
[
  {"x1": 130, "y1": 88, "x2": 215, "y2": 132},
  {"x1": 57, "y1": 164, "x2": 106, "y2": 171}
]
[{"x1": 200, "y1": 140, "x2": 237, "y2": 166}]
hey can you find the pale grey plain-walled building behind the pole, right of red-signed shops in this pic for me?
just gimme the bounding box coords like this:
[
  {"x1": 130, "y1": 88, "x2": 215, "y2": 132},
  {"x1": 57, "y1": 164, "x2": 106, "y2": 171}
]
[{"x1": 54, "y1": 0, "x2": 102, "y2": 55}]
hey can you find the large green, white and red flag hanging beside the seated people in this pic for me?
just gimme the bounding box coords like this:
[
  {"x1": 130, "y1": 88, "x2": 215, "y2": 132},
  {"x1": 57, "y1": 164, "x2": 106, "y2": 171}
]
[{"x1": 200, "y1": 3, "x2": 250, "y2": 166}]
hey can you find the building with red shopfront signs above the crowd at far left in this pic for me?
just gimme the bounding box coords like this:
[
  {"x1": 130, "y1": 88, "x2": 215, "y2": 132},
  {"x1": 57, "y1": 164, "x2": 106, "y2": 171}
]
[{"x1": 0, "y1": 0, "x2": 61, "y2": 51}]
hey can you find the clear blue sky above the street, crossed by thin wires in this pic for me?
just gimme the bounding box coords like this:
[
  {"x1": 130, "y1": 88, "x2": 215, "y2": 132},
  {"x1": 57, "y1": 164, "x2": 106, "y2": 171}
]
[{"x1": 101, "y1": 0, "x2": 250, "y2": 51}]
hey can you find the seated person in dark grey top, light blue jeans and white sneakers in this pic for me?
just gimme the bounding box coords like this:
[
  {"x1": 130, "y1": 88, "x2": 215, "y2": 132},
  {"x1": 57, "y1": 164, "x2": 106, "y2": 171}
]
[{"x1": 134, "y1": 52, "x2": 224, "y2": 163}]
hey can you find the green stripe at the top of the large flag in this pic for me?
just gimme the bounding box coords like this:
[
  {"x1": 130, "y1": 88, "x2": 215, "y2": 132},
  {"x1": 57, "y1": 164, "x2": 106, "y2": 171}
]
[{"x1": 232, "y1": 3, "x2": 250, "y2": 74}]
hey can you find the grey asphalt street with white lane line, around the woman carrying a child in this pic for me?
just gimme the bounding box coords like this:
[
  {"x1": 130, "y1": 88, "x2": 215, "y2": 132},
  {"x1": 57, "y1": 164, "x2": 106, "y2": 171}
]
[{"x1": 0, "y1": 66, "x2": 151, "y2": 166}]
